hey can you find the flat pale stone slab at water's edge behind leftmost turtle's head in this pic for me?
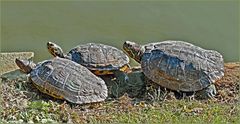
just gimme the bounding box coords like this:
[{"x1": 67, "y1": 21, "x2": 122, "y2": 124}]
[{"x1": 0, "y1": 52, "x2": 34, "y2": 75}]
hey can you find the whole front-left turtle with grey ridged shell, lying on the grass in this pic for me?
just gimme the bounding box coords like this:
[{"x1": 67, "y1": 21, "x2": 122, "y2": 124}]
[{"x1": 15, "y1": 57, "x2": 108, "y2": 104}]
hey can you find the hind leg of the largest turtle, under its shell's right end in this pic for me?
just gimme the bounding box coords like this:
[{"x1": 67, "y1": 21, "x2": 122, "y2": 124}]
[{"x1": 195, "y1": 84, "x2": 217, "y2": 99}]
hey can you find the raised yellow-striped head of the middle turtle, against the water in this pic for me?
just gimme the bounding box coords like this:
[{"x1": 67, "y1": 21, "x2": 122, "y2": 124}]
[{"x1": 47, "y1": 42, "x2": 64, "y2": 58}]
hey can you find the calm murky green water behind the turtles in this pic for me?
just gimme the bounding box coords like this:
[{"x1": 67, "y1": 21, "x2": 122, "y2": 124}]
[{"x1": 1, "y1": 1, "x2": 240, "y2": 61}]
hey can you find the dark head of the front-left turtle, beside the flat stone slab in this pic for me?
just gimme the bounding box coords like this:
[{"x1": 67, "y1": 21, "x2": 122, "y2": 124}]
[{"x1": 15, "y1": 59, "x2": 36, "y2": 74}]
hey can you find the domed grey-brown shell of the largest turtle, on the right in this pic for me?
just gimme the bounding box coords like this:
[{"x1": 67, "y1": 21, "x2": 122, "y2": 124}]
[{"x1": 141, "y1": 41, "x2": 224, "y2": 92}]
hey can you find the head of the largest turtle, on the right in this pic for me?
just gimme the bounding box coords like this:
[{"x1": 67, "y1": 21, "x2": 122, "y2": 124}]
[{"x1": 123, "y1": 41, "x2": 144, "y2": 63}]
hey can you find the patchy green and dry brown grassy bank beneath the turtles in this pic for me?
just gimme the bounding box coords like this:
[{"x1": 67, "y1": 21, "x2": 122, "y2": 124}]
[{"x1": 0, "y1": 64, "x2": 240, "y2": 124}]
